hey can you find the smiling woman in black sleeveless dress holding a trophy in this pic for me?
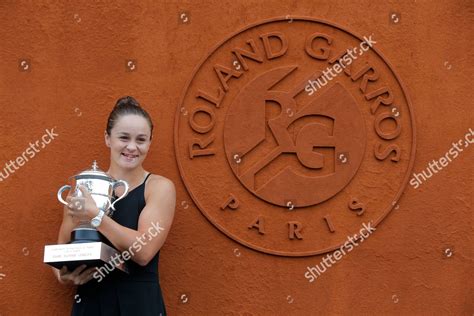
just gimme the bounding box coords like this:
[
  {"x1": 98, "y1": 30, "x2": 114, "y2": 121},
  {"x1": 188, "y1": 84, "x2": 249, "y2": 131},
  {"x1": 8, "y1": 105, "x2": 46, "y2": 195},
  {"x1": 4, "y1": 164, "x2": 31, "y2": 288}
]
[{"x1": 54, "y1": 97, "x2": 176, "y2": 316}]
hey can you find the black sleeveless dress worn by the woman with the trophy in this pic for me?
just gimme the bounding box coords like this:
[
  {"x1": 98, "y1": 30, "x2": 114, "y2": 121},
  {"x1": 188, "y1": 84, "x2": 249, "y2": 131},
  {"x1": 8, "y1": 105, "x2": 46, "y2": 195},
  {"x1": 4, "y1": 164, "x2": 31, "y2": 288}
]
[{"x1": 71, "y1": 174, "x2": 166, "y2": 316}]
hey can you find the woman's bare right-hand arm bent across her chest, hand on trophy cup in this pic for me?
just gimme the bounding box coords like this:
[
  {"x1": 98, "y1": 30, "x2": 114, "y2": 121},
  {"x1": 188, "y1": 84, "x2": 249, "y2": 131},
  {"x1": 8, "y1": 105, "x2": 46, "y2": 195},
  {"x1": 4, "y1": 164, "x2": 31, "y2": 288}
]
[{"x1": 71, "y1": 178, "x2": 176, "y2": 266}]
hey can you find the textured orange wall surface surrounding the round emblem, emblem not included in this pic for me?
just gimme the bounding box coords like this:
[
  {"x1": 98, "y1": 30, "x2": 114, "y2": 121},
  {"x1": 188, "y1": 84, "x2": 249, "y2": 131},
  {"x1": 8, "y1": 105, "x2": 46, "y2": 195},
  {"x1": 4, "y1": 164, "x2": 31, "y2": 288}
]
[{"x1": 0, "y1": 0, "x2": 474, "y2": 315}]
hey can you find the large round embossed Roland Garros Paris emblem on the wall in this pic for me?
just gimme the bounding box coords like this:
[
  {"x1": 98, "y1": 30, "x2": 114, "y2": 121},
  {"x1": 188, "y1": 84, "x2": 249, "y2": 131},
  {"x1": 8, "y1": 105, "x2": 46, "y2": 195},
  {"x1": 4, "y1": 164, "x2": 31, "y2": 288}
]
[{"x1": 175, "y1": 17, "x2": 415, "y2": 256}]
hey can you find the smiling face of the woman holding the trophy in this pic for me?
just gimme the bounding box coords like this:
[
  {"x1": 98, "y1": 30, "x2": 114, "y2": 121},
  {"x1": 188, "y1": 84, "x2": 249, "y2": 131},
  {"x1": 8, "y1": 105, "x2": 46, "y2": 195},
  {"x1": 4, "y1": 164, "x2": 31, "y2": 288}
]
[{"x1": 105, "y1": 114, "x2": 151, "y2": 169}]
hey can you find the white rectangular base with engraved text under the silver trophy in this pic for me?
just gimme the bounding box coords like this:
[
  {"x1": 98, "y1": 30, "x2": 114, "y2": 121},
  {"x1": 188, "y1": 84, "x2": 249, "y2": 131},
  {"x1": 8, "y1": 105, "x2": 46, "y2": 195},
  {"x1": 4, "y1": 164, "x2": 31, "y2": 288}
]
[{"x1": 43, "y1": 242, "x2": 128, "y2": 273}]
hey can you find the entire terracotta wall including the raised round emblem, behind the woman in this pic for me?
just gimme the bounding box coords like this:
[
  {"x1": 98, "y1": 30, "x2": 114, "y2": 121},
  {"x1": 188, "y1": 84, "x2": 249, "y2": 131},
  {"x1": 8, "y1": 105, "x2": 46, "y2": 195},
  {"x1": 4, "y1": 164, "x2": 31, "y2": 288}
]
[{"x1": 0, "y1": 0, "x2": 474, "y2": 315}]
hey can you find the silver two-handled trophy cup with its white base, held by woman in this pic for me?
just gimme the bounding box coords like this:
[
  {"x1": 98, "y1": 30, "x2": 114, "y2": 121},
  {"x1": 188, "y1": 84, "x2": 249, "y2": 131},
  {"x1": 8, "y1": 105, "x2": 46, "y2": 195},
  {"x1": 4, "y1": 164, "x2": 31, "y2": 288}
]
[{"x1": 43, "y1": 161, "x2": 128, "y2": 272}]
